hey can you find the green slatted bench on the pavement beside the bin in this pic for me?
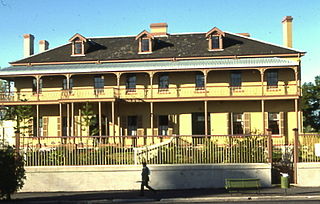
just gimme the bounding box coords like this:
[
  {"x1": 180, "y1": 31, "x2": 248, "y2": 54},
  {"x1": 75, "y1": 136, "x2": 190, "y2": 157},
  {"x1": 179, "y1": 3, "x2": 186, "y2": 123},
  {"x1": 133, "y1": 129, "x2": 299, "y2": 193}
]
[{"x1": 225, "y1": 178, "x2": 261, "y2": 193}]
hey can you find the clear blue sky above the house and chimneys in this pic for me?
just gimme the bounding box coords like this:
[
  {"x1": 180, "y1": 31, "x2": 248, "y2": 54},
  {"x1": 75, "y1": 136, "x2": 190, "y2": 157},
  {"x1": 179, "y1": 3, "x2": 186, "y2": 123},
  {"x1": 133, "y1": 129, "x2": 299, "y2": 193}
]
[{"x1": 0, "y1": 0, "x2": 320, "y2": 82}]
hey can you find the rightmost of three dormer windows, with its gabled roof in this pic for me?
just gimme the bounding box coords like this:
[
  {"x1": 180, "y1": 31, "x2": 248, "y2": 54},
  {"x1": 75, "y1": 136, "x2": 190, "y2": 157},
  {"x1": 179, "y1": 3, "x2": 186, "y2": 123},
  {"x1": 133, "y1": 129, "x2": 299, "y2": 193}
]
[{"x1": 206, "y1": 27, "x2": 225, "y2": 51}]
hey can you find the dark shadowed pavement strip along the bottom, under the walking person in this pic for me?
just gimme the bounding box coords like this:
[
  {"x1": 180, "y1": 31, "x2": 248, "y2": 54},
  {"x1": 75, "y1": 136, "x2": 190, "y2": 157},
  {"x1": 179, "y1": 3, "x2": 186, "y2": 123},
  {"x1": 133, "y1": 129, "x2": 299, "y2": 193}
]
[{"x1": 0, "y1": 186, "x2": 320, "y2": 204}]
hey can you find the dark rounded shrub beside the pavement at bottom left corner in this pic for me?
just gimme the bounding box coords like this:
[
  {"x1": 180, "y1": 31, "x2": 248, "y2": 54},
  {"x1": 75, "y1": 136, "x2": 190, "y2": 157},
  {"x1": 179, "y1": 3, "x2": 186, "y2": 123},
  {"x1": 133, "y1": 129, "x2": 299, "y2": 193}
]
[{"x1": 0, "y1": 146, "x2": 26, "y2": 200}]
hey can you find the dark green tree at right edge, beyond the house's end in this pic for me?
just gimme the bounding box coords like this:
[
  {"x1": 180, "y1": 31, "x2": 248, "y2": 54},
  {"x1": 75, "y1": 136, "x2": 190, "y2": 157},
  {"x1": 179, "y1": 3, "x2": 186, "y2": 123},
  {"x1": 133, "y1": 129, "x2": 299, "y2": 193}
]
[{"x1": 301, "y1": 76, "x2": 320, "y2": 132}]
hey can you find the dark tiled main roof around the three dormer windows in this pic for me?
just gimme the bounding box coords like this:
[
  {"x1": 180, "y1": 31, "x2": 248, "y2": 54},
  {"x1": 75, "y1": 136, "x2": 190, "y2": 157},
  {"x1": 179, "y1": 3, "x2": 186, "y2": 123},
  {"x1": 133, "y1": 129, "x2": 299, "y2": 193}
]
[{"x1": 13, "y1": 33, "x2": 299, "y2": 63}]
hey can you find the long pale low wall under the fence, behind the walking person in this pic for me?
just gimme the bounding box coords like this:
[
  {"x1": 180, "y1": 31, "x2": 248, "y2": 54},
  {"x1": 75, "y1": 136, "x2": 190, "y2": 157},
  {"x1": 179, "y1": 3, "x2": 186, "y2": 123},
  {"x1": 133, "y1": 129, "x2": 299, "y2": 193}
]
[{"x1": 21, "y1": 164, "x2": 271, "y2": 192}]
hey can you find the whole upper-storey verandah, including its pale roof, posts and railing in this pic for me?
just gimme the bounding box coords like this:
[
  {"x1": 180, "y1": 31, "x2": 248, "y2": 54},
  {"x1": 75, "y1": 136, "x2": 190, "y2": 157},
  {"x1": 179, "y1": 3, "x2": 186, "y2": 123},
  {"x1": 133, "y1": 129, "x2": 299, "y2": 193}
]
[{"x1": 0, "y1": 58, "x2": 301, "y2": 103}]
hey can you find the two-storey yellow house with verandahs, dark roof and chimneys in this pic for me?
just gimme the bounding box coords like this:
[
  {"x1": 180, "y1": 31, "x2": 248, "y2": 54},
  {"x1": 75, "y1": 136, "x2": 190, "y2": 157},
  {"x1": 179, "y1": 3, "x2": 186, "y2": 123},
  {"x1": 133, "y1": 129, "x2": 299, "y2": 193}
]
[{"x1": 0, "y1": 16, "x2": 304, "y2": 146}]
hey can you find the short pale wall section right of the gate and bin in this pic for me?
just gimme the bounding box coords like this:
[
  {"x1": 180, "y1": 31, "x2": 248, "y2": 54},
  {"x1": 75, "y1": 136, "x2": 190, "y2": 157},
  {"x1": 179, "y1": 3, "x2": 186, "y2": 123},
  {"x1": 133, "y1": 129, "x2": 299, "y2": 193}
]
[{"x1": 297, "y1": 162, "x2": 320, "y2": 187}]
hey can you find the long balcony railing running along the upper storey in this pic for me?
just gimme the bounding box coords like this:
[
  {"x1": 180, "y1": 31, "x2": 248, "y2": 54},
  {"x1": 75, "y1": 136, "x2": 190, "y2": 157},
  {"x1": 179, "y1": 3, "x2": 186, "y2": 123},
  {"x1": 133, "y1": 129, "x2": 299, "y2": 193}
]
[{"x1": 0, "y1": 84, "x2": 300, "y2": 102}]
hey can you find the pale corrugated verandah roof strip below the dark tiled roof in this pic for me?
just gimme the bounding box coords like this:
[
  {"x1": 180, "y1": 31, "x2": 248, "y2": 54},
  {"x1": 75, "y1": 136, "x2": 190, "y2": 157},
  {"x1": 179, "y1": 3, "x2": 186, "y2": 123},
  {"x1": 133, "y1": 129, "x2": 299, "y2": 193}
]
[{"x1": 0, "y1": 58, "x2": 299, "y2": 77}]
